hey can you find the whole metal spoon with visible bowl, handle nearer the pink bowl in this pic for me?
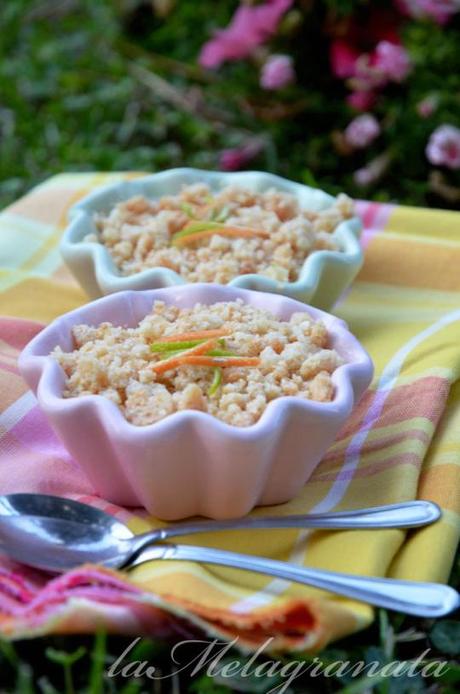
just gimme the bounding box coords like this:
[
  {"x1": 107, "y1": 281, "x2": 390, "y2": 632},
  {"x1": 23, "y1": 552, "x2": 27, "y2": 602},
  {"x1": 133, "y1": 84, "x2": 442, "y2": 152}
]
[{"x1": 0, "y1": 494, "x2": 441, "y2": 572}]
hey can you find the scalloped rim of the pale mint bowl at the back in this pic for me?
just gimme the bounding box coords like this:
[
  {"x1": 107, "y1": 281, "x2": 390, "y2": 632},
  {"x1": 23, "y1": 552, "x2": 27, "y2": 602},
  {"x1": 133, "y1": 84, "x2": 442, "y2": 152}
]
[{"x1": 60, "y1": 172, "x2": 363, "y2": 300}]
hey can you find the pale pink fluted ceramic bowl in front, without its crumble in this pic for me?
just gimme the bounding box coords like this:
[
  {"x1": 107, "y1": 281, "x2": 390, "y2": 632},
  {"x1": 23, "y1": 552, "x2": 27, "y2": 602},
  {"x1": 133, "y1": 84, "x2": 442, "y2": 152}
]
[{"x1": 19, "y1": 284, "x2": 373, "y2": 520}]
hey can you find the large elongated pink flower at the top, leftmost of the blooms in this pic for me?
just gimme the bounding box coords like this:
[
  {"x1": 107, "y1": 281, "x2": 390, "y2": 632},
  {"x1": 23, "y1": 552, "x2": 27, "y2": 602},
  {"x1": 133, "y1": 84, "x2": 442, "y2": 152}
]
[{"x1": 198, "y1": 0, "x2": 293, "y2": 68}]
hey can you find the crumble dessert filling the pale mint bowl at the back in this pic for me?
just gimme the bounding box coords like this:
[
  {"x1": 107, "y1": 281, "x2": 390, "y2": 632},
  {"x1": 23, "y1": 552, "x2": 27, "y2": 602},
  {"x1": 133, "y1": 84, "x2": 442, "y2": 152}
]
[{"x1": 84, "y1": 183, "x2": 354, "y2": 284}]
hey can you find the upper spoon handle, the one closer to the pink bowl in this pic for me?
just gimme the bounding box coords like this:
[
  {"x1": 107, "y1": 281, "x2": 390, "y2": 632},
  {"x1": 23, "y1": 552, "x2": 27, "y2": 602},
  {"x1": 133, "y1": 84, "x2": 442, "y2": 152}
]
[{"x1": 135, "y1": 501, "x2": 441, "y2": 550}]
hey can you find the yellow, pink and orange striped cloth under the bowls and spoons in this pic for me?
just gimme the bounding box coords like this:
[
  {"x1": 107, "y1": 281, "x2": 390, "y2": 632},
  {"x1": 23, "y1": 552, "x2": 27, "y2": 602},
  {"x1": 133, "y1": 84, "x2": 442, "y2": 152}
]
[{"x1": 0, "y1": 174, "x2": 460, "y2": 651}]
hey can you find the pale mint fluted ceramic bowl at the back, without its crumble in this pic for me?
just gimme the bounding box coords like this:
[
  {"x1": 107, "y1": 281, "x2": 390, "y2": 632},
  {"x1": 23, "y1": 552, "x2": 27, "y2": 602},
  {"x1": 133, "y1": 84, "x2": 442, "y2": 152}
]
[{"x1": 60, "y1": 168, "x2": 363, "y2": 310}]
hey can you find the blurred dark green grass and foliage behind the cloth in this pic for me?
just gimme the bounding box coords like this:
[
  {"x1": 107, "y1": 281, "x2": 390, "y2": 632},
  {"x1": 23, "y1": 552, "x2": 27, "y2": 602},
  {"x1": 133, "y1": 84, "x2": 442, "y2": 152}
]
[{"x1": 0, "y1": 0, "x2": 460, "y2": 207}]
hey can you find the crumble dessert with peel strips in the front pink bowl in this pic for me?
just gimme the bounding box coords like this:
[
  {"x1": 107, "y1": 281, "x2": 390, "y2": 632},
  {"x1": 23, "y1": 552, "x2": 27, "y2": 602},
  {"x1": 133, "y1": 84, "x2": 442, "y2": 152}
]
[{"x1": 52, "y1": 300, "x2": 343, "y2": 427}]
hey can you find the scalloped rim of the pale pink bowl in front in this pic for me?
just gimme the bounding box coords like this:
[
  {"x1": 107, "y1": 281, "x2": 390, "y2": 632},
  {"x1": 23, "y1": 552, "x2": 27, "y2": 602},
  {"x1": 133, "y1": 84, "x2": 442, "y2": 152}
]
[{"x1": 19, "y1": 283, "x2": 373, "y2": 440}]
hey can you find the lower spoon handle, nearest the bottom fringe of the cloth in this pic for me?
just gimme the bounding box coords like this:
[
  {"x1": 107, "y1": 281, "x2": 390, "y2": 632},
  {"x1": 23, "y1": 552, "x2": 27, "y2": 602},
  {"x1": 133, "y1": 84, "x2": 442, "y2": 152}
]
[{"x1": 128, "y1": 544, "x2": 460, "y2": 617}]
